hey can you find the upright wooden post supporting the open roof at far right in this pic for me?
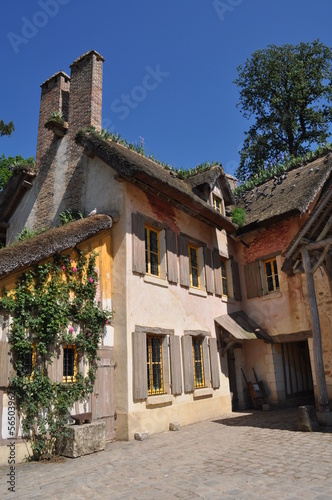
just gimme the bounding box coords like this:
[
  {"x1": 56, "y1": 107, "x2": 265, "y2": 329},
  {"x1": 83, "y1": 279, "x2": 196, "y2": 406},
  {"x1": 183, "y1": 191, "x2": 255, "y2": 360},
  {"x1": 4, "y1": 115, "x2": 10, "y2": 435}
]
[{"x1": 301, "y1": 247, "x2": 330, "y2": 413}]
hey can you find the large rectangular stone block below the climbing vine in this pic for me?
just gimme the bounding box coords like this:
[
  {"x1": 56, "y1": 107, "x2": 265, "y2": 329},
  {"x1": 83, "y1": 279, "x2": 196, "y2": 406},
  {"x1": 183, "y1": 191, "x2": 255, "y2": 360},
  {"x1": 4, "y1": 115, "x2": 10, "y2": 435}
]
[{"x1": 57, "y1": 421, "x2": 105, "y2": 458}]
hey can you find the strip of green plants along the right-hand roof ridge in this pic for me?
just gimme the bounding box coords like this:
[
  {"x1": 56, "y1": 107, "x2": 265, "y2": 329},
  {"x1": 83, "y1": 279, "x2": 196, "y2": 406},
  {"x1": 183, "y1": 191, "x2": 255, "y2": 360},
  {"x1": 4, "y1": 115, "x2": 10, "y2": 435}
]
[{"x1": 233, "y1": 143, "x2": 332, "y2": 196}]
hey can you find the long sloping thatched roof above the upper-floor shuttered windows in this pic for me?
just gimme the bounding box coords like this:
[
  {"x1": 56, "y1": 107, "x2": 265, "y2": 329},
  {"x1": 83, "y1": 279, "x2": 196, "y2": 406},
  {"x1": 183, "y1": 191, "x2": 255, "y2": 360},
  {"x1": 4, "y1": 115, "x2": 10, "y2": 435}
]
[{"x1": 78, "y1": 134, "x2": 235, "y2": 233}]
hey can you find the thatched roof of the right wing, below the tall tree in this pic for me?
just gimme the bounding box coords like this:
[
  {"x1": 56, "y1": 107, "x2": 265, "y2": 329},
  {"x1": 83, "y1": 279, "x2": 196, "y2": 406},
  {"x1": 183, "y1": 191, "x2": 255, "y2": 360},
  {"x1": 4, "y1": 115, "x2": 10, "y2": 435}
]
[{"x1": 236, "y1": 153, "x2": 332, "y2": 233}]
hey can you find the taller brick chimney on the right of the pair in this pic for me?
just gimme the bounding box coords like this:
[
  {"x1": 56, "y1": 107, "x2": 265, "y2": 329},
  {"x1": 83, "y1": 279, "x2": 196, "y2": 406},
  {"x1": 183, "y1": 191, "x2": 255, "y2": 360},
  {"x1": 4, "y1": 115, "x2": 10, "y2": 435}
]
[{"x1": 68, "y1": 50, "x2": 104, "y2": 137}]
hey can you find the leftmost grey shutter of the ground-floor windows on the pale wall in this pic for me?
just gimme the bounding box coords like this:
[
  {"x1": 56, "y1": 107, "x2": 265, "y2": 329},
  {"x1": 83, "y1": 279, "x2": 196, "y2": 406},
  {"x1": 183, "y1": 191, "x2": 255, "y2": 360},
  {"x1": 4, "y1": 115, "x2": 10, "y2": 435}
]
[{"x1": 133, "y1": 332, "x2": 148, "y2": 401}]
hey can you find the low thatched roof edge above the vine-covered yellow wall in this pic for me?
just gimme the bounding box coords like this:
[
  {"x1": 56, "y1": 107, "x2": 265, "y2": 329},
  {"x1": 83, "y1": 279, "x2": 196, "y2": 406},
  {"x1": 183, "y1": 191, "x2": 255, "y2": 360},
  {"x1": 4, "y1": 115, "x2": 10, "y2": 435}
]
[{"x1": 0, "y1": 215, "x2": 112, "y2": 277}]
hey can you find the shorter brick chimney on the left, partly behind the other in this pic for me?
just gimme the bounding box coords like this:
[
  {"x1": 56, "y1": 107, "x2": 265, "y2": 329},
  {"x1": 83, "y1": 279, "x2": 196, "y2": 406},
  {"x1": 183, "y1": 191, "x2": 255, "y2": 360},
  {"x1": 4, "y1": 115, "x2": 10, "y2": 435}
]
[{"x1": 36, "y1": 71, "x2": 70, "y2": 168}]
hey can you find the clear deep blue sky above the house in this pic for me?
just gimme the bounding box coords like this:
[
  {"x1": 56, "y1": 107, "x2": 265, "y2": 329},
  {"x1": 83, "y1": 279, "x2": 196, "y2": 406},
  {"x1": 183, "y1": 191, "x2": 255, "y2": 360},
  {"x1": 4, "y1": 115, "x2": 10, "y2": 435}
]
[{"x1": 0, "y1": 0, "x2": 332, "y2": 178}]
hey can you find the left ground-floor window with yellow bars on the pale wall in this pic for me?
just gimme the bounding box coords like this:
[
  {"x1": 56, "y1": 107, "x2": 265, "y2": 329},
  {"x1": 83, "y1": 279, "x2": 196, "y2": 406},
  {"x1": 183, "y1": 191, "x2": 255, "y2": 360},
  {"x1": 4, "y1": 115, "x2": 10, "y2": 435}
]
[{"x1": 146, "y1": 335, "x2": 164, "y2": 396}]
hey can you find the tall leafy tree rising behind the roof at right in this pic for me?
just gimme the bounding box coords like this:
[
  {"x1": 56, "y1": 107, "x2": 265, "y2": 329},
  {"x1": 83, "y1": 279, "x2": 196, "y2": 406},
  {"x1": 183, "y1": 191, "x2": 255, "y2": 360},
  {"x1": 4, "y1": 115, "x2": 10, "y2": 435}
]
[{"x1": 234, "y1": 40, "x2": 332, "y2": 180}]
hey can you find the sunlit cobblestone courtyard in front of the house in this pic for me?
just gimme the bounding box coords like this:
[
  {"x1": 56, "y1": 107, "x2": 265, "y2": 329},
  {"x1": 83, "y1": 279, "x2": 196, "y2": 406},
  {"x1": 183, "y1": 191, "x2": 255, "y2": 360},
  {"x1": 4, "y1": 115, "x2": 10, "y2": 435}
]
[{"x1": 0, "y1": 409, "x2": 332, "y2": 500}]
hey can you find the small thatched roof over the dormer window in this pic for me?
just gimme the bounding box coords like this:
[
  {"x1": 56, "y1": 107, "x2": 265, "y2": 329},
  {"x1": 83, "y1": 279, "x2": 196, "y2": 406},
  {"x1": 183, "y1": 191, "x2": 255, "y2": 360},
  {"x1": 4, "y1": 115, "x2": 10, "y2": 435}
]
[{"x1": 185, "y1": 165, "x2": 234, "y2": 205}]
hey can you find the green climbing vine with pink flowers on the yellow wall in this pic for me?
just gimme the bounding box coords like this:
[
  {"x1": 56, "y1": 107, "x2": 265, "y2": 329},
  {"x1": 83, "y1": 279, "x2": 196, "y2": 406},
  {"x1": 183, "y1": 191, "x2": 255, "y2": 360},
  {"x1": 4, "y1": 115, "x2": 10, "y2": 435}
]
[{"x1": 0, "y1": 249, "x2": 111, "y2": 460}]
